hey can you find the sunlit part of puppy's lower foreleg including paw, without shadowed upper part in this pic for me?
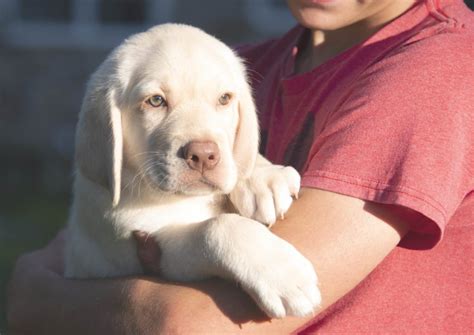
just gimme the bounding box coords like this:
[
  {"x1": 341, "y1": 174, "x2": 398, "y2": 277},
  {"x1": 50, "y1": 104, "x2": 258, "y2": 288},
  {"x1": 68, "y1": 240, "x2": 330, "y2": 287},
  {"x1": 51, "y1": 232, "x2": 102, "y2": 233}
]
[{"x1": 212, "y1": 214, "x2": 321, "y2": 318}]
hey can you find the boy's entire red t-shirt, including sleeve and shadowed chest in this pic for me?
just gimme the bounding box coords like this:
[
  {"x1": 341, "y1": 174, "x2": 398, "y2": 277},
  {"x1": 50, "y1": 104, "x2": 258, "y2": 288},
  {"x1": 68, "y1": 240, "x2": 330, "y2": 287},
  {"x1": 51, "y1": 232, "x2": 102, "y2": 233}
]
[{"x1": 239, "y1": 0, "x2": 474, "y2": 334}]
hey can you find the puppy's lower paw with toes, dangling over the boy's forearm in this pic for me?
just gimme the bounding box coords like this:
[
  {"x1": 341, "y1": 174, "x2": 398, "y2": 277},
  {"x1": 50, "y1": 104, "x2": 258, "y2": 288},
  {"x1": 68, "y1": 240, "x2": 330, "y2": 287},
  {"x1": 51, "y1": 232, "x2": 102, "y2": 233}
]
[{"x1": 245, "y1": 235, "x2": 321, "y2": 318}]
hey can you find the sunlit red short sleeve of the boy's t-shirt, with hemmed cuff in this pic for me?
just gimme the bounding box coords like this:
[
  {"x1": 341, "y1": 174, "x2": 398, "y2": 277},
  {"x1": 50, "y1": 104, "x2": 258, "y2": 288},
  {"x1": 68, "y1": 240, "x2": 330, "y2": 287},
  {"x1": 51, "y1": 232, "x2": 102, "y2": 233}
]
[{"x1": 302, "y1": 36, "x2": 474, "y2": 249}]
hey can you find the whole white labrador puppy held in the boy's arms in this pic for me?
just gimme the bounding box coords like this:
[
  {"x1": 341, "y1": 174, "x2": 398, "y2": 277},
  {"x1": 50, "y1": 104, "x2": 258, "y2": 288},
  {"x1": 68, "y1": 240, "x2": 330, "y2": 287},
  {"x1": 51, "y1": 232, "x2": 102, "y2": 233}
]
[{"x1": 65, "y1": 24, "x2": 320, "y2": 317}]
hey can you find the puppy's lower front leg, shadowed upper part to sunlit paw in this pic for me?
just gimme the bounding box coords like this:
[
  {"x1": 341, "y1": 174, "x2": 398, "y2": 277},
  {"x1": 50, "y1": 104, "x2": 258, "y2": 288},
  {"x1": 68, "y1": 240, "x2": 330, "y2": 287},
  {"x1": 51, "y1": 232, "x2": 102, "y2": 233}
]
[{"x1": 156, "y1": 214, "x2": 321, "y2": 318}]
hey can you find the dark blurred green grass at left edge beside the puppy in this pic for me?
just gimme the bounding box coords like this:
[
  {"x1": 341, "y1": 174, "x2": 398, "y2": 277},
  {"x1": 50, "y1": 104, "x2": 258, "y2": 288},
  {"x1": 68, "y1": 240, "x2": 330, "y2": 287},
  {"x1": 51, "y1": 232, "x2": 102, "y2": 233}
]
[{"x1": 0, "y1": 192, "x2": 70, "y2": 334}]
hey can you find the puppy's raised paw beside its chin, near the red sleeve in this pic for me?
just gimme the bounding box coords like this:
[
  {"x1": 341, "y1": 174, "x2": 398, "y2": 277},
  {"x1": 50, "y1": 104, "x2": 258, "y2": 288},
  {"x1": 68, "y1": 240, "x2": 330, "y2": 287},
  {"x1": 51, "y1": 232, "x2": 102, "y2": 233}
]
[{"x1": 229, "y1": 164, "x2": 301, "y2": 226}]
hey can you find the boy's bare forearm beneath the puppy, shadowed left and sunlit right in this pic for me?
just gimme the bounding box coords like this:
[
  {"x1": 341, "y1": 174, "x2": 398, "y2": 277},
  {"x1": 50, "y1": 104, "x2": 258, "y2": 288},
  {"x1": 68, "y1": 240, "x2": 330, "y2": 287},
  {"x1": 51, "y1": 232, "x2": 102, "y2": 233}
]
[{"x1": 8, "y1": 251, "x2": 286, "y2": 335}]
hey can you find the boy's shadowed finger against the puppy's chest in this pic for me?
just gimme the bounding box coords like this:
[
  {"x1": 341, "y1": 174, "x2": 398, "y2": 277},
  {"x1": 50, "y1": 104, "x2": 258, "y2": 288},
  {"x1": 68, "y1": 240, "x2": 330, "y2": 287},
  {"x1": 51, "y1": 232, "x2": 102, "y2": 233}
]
[{"x1": 133, "y1": 231, "x2": 161, "y2": 275}]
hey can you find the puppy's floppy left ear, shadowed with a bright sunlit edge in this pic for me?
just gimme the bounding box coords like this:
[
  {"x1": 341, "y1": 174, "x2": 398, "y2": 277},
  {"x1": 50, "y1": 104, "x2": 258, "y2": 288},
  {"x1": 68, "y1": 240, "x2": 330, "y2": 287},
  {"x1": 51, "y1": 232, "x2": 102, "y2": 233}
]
[{"x1": 75, "y1": 82, "x2": 123, "y2": 206}]
